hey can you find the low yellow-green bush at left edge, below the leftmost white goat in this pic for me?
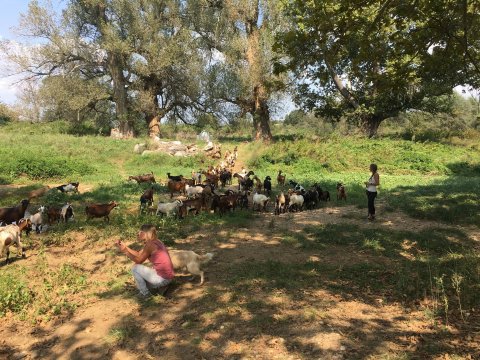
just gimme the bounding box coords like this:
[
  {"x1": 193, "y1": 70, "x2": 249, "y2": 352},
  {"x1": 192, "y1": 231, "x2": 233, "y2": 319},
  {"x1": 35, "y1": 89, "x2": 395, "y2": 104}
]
[{"x1": 0, "y1": 270, "x2": 32, "y2": 317}]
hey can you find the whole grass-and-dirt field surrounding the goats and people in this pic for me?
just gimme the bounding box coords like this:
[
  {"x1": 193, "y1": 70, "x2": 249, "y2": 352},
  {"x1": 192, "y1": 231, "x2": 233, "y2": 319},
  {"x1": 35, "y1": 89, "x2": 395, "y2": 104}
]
[{"x1": 0, "y1": 124, "x2": 480, "y2": 359}]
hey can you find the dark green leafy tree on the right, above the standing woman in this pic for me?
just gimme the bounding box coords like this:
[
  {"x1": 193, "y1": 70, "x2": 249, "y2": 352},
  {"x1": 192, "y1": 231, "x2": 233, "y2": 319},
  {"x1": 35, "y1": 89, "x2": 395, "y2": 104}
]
[{"x1": 276, "y1": 0, "x2": 478, "y2": 137}]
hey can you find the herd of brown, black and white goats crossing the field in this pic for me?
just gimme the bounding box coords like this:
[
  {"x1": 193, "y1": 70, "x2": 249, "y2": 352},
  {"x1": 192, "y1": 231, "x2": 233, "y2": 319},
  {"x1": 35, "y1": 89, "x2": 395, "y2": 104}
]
[{"x1": 0, "y1": 149, "x2": 347, "y2": 263}]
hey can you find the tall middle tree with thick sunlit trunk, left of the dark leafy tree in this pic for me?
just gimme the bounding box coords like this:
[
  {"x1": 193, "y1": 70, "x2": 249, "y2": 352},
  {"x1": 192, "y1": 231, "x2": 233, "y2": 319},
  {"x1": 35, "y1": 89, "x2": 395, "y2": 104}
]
[{"x1": 189, "y1": 0, "x2": 286, "y2": 141}]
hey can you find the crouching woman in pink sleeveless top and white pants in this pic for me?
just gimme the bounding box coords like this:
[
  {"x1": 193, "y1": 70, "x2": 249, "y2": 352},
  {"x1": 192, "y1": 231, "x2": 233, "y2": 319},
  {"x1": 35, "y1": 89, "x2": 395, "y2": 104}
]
[{"x1": 115, "y1": 224, "x2": 175, "y2": 298}]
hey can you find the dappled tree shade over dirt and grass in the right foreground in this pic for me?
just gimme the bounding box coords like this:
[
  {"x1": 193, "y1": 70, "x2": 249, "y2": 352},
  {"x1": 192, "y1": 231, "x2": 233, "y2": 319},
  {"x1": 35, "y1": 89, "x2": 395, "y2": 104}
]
[{"x1": 79, "y1": 219, "x2": 480, "y2": 359}]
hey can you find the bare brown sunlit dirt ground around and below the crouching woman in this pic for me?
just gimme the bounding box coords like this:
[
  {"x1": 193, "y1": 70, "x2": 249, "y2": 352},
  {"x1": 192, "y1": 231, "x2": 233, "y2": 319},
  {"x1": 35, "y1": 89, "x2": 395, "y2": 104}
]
[{"x1": 0, "y1": 198, "x2": 480, "y2": 360}]
